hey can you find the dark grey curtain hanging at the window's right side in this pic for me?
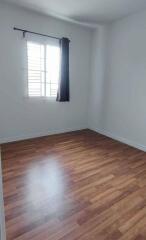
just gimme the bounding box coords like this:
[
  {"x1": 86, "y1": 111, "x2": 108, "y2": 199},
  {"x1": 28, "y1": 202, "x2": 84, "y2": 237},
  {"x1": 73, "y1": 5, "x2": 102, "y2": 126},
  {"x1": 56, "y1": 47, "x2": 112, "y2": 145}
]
[{"x1": 56, "y1": 38, "x2": 70, "y2": 102}]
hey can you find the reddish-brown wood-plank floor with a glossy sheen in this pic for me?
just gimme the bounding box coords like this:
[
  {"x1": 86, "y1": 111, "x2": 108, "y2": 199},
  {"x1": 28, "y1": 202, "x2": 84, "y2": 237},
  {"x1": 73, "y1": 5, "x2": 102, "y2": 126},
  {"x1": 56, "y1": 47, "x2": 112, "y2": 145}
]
[{"x1": 2, "y1": 130, "x2": 146, "y2": 240}]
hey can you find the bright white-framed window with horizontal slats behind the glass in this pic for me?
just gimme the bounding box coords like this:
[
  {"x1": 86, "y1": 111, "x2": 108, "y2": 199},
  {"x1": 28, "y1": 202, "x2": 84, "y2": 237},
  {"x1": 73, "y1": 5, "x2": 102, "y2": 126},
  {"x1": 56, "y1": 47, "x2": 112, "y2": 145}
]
[{"x1": 27, "y1": 41, "x2": 60, "y2": 97}]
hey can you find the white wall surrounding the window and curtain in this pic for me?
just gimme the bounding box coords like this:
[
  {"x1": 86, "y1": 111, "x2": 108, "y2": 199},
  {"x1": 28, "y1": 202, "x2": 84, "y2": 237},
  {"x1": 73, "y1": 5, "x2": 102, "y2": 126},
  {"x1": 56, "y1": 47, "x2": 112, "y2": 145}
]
[{"x1": 0, "y1": 5, "x2": 92, "y2": 143}]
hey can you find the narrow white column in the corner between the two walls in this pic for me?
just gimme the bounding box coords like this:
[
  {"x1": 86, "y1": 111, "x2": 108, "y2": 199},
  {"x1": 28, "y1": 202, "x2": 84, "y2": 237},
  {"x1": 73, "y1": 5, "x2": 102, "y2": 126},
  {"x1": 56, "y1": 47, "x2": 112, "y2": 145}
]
[{"x1": 88, "y1": 26, "x2": 108, "y2": 129}]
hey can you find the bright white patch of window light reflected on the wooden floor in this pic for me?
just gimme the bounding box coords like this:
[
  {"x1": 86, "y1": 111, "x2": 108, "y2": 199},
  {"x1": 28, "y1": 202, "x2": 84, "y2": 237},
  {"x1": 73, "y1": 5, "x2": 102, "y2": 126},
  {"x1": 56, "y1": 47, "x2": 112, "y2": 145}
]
[{"x1": 26, "y1": 159, "x2": 66, "y2": 214}]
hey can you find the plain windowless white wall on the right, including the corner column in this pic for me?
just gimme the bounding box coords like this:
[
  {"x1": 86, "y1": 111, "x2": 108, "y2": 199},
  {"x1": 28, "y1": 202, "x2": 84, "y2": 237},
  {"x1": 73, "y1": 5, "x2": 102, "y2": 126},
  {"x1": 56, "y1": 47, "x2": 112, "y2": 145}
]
[{"x1": 89, "y1": 12, "x2": 146, "y2": 150}]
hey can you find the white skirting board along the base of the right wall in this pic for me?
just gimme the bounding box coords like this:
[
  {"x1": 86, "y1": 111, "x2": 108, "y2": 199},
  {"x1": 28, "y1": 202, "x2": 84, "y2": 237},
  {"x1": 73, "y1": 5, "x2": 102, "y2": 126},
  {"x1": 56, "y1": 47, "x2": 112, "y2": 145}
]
[{"x1": 90, "y1": 128, "x2": 146, "y2": 152}]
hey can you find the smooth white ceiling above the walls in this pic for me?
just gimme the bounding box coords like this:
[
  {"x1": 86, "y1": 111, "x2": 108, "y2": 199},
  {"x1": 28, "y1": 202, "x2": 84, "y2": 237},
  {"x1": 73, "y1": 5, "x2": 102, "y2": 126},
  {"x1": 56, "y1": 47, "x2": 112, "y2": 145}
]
[{"x1": 0, "y1": 0, "x2": 146, "y2": 25}]
